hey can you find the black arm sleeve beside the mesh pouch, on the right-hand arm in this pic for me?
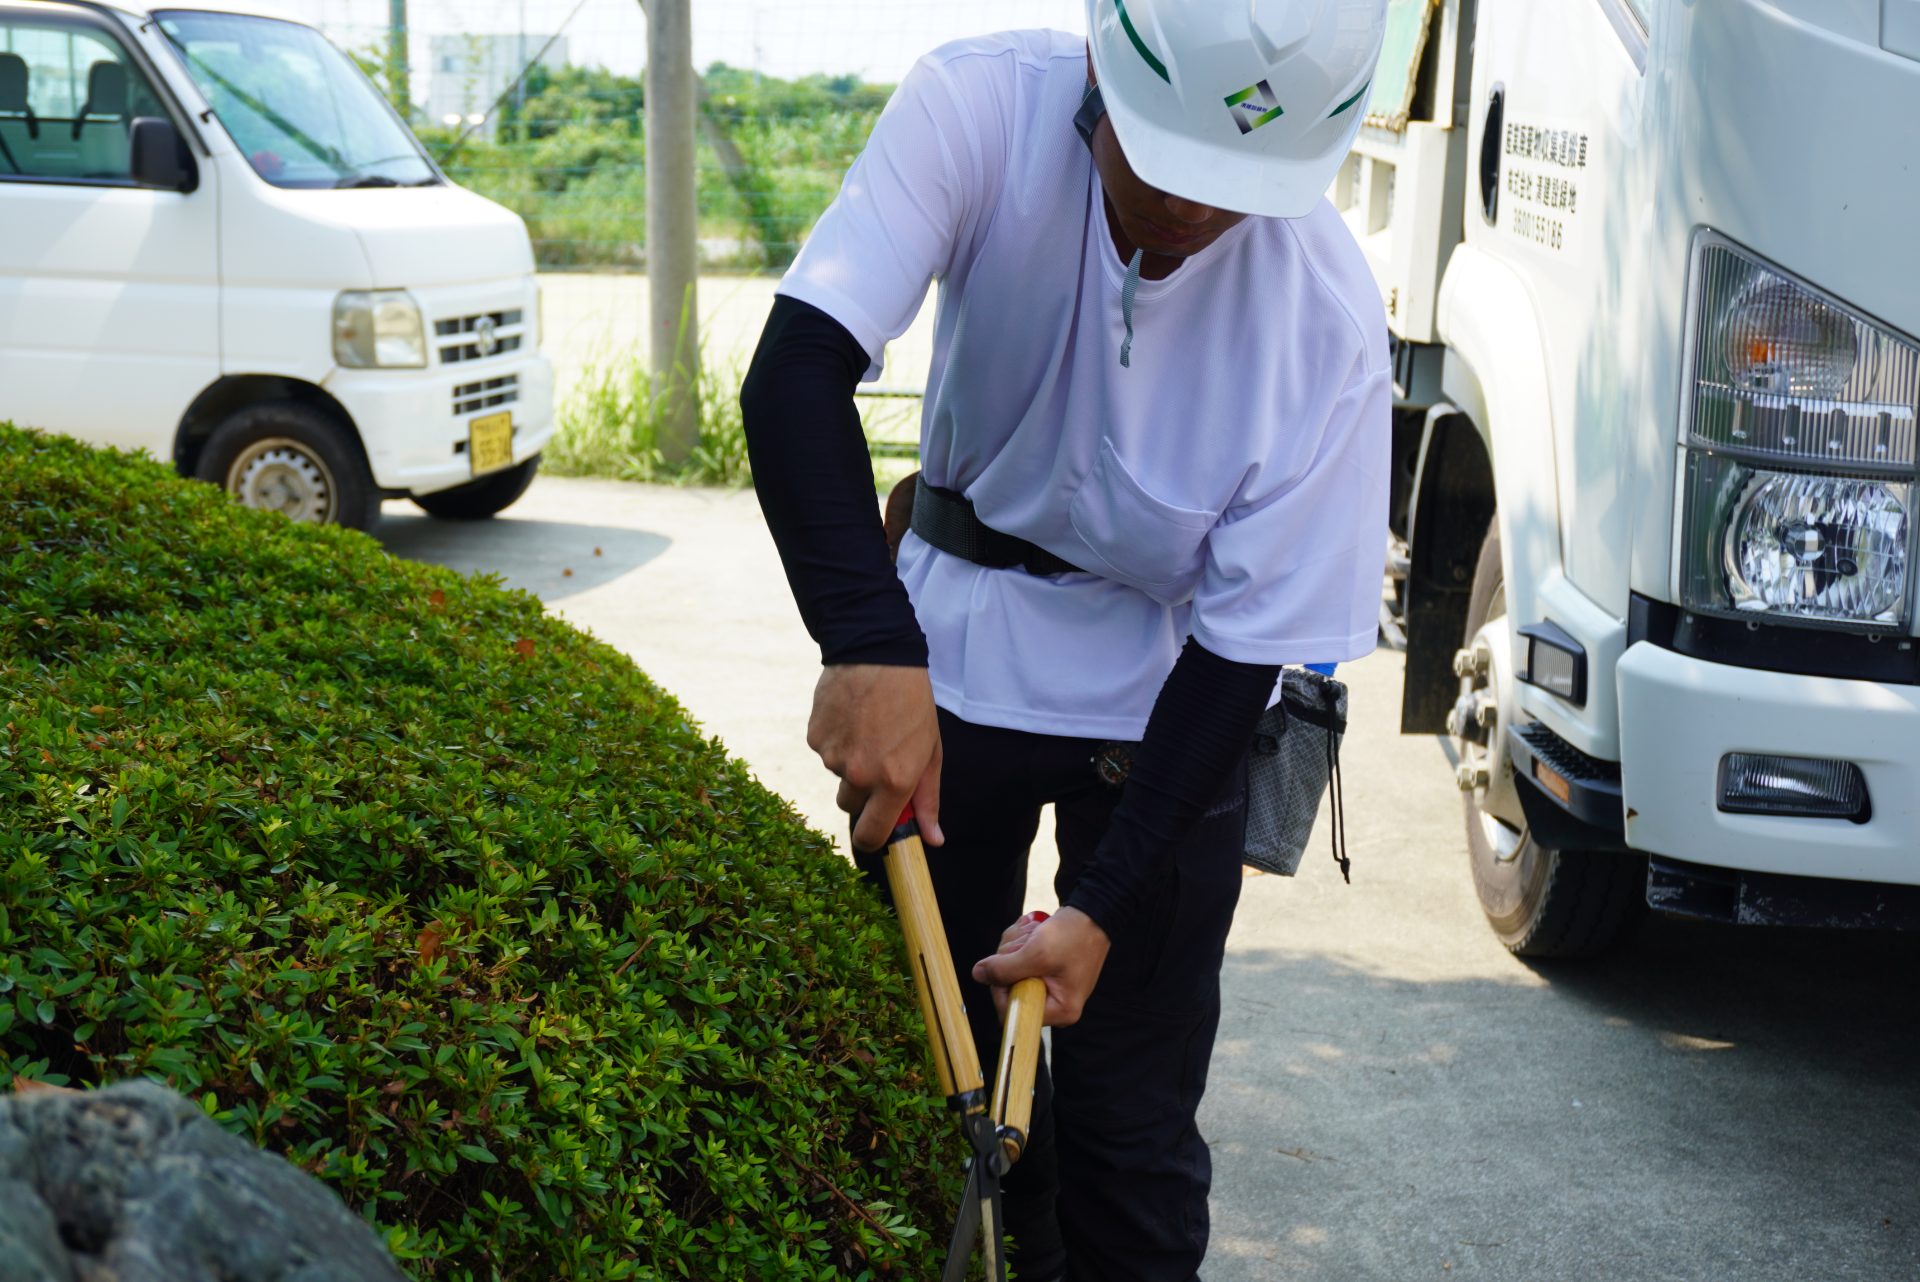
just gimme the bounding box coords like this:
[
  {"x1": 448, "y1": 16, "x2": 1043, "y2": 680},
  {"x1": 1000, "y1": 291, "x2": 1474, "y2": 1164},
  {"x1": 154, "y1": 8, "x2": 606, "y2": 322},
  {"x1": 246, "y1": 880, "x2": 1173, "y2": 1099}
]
[{"x1": 1068, "y1": 639, "x2": 1281, "y2": 935}]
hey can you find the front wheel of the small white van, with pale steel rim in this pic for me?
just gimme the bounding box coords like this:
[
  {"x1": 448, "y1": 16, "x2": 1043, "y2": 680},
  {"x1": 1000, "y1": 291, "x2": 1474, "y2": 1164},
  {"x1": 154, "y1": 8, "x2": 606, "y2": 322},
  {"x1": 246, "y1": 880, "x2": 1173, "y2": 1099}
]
[{"x1": 194, "y1": 401, "x2": 380, "y2": 530}]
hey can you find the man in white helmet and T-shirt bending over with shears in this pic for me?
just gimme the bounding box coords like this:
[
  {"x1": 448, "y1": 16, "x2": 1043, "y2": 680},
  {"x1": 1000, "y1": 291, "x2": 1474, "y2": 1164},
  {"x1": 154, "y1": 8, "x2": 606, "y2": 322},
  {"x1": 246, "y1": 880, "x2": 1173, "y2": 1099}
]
[{"x1": 741, "y1": 0, "x2": 1390, "y2": 1282}]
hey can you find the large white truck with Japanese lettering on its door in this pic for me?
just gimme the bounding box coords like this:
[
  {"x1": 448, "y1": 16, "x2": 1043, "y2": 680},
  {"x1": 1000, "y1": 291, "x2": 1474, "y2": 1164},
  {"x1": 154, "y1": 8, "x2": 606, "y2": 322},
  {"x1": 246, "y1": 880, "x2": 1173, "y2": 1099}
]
[{"x1": 1334, "y1": 0, "x2": 1920, "y2": 956}]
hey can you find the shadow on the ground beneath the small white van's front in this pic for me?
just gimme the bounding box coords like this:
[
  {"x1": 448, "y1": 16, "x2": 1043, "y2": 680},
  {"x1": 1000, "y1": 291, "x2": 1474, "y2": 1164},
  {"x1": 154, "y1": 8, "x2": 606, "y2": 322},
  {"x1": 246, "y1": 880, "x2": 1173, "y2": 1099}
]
[{"x1": 372, "y1": 505, "x2": 672, "y2": 603}]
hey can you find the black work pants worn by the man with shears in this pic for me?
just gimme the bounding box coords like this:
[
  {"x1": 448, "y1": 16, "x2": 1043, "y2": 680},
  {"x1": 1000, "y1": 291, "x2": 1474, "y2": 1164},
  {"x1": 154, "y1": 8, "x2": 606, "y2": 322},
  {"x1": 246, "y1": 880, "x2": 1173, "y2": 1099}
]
[{"x1": 858, "y1": 710, "x2": 1246, "y2": 1282}]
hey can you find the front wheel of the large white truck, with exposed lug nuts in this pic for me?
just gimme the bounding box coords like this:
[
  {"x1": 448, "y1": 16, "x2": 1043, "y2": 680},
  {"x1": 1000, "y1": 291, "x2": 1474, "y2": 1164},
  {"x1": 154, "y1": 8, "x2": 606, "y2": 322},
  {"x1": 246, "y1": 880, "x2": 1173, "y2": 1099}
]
[{"x1": 1452, "y1": 520, "x2": 1647, "y2": 958}]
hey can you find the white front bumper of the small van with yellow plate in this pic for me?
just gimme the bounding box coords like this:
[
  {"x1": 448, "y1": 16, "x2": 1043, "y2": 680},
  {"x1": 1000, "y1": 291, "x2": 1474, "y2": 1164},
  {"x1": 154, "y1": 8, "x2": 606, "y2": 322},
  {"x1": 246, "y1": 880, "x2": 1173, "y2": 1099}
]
[{"x1": 323, "y1": 349, "x2": 553, "y2": 493}]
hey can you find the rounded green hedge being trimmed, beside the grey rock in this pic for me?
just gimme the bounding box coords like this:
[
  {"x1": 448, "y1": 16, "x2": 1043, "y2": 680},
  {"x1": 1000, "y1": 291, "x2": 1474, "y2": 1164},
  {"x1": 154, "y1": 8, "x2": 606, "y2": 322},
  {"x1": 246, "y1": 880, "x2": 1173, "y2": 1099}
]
[{"x1": 0, "y1": 426, "x2": 958, "y2": 1282}]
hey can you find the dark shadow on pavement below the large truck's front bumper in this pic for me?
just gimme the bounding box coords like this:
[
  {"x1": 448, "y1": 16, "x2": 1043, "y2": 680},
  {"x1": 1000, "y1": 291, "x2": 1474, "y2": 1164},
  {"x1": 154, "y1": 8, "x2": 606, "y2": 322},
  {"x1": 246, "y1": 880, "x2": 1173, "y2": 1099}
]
[{"x1": 1202, "y1": 919, "x2": 1920, "y2": 1282}]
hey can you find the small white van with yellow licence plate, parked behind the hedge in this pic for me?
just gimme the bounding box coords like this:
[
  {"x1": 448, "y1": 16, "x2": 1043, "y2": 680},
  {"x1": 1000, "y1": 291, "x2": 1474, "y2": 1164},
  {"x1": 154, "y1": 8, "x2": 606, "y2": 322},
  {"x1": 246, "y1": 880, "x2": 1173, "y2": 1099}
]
[{"x1": 0, "y1": 0, "x2": 553, "y2": 528}]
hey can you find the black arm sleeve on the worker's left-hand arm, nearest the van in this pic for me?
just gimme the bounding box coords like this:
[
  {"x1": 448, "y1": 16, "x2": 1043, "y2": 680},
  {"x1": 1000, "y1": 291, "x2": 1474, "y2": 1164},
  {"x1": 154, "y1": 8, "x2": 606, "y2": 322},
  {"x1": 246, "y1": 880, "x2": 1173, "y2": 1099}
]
[{"x1": 739, "y1": 296, "x2": 927, "y2": 668}]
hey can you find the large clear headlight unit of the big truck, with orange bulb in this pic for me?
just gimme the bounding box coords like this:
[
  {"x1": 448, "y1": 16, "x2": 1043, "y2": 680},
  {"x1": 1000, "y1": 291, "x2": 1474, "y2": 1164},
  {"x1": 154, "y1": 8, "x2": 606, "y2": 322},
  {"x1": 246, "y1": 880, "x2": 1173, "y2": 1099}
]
[{"x1": 1680, "y1": 232, "x2": 1920, "y2": 633}]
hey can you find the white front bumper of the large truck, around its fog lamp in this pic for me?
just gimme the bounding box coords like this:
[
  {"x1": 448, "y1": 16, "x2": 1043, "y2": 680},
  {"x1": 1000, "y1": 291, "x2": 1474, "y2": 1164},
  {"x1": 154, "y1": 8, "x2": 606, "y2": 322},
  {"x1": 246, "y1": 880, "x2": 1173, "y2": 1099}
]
[{"x1": 1617, "y1": 641, "x2": 1920, "y2": 885}]
